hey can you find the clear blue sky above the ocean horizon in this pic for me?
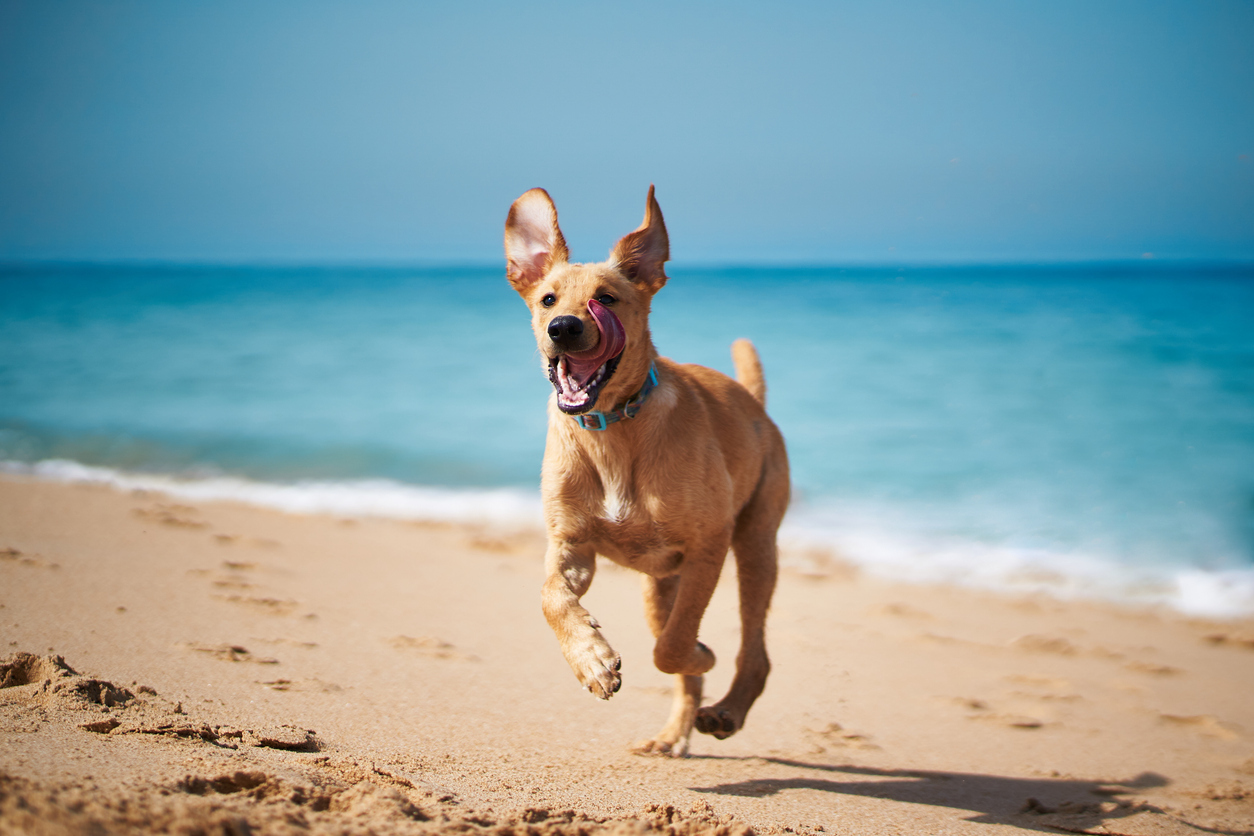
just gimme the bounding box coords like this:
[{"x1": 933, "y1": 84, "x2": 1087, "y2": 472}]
[{"x1": 0, "y1": 0, "x2": 1254, "y2": 264}]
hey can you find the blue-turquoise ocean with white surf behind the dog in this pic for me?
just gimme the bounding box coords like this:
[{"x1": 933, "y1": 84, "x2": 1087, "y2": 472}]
[{"x1": 0, "y1": 262, "x2": 1254, "y2": 617}]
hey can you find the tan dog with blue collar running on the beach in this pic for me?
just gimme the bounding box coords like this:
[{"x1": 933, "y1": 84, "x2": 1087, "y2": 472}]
[{"x1": 505, "y1": 187, "x2": 789, "y2": 757}]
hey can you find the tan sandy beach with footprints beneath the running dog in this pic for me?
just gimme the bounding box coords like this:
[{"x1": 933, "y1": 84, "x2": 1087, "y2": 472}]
[{"x1": 0, "y1": 476, "x2": 1254, "y2": 835}]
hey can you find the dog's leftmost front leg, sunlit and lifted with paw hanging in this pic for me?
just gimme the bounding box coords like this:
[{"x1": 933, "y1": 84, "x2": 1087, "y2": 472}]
[{"x1": 542, "y1": 540, "x2": 622, "y2": 699}]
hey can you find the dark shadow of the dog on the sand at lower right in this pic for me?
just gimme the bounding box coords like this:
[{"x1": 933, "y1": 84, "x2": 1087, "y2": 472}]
[{"x1": 688, "y1": 756, "x2": 1254, "y2": 836}]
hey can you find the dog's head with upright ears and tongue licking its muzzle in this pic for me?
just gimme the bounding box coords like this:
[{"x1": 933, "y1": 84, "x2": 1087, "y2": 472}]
[{"x1": 505, "y1": 185, "x2": 671, "y2": 415}]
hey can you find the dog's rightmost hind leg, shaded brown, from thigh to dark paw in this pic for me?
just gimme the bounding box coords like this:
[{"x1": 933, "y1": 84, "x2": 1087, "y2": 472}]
[{"x1": 695, "y1": 491, "x2": 788, "y2": 739}]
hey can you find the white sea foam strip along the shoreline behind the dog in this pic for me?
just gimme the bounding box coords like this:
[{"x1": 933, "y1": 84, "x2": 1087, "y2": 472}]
[{"x1": 0, "y1": 459, "x2": 1254, "y2": 618}]
